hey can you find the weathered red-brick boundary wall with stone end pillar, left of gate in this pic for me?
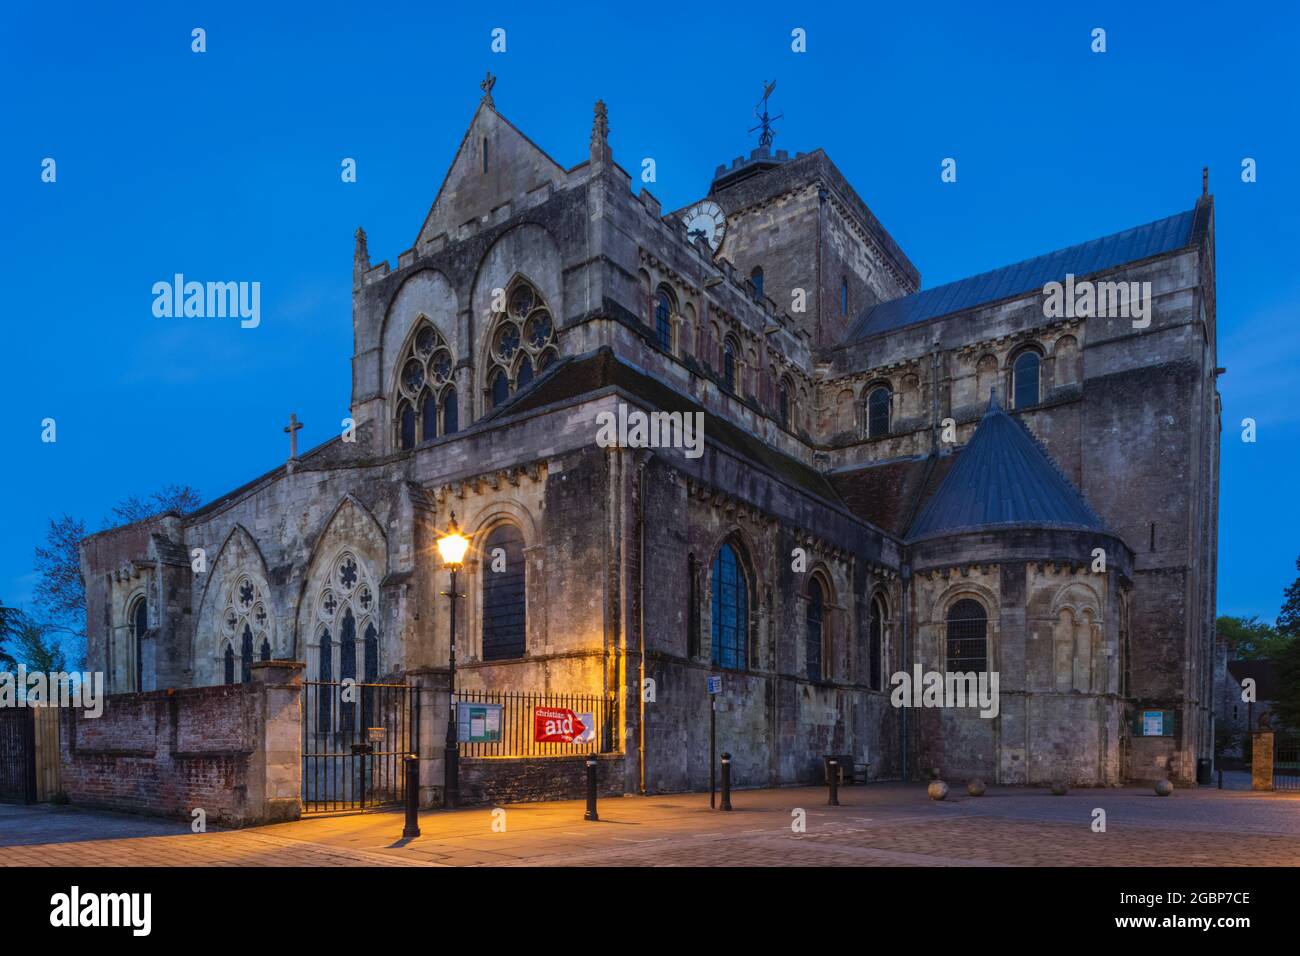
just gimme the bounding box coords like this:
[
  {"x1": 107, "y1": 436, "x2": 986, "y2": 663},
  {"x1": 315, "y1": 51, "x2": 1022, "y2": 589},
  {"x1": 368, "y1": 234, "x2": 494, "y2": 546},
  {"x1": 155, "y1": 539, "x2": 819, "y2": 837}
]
[{"x1": 60, "y1": 662, "x2": 302, "y2": 826}]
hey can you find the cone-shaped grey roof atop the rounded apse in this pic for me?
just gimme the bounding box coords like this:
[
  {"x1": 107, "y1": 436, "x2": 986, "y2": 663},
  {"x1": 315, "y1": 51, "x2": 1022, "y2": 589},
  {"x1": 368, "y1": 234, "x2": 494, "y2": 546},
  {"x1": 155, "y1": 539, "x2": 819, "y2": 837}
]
[{"x1": 907, "y1": 393, "x2": 1102, "y2": 541}]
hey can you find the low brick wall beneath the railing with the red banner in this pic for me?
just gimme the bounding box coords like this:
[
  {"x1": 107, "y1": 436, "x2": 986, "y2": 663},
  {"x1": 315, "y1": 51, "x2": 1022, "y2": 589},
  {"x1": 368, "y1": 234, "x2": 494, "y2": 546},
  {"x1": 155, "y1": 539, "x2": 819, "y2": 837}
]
[{"x1": 460, "y1": 754, "x2": 623, "y2": 806}]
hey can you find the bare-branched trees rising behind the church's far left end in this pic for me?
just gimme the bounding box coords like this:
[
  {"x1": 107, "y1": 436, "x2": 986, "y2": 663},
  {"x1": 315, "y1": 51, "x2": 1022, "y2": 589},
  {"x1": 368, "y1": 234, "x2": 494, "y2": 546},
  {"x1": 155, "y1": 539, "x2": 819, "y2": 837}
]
[{"x1": 35, "y1": 485, "x2": 203, "y2": 650}]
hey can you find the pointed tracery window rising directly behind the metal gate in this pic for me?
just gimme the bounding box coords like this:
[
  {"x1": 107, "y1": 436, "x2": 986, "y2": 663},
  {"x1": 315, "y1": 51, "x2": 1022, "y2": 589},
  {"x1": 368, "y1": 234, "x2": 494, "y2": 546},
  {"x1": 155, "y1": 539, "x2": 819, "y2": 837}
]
[{"x1": 315, "y1": 551, "x2": 380, "y2": 732}]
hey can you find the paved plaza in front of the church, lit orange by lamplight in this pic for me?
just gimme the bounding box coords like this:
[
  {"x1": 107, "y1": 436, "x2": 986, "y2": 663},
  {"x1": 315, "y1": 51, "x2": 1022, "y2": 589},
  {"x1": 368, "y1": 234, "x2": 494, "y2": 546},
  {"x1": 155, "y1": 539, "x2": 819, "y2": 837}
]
[{"x1": 0, "y1": 784, "x2": 1300, "y2": 866}]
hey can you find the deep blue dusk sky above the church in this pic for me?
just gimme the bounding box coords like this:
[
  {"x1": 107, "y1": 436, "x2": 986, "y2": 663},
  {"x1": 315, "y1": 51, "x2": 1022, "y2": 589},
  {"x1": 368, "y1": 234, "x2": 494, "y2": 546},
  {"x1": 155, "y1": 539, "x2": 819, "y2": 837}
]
[{"x1": 0, "y1": 3, "x2": 1300, "y2": 619}]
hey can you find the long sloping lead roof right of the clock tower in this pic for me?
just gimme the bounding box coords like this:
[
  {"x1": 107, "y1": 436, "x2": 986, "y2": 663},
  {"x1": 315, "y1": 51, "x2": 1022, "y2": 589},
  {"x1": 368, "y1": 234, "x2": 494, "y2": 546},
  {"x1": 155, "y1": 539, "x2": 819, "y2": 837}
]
[{"x1": 848, "y1": 209, "x2": 1196, "y2": 342}]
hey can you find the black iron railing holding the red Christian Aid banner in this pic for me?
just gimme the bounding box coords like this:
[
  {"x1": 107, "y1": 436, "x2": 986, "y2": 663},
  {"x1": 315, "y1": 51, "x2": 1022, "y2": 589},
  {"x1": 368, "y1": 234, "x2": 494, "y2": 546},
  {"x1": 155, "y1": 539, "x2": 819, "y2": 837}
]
[{"x1": 456, "y1": 691, "x2": 619, "y2": 757}]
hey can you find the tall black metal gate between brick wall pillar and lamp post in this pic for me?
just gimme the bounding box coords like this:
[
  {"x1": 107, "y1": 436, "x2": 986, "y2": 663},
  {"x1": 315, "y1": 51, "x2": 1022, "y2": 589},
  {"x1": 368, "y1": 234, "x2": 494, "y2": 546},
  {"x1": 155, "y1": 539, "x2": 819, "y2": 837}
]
[{"x1": 303, "y1": 680, "x2": 420, "y2": 813}]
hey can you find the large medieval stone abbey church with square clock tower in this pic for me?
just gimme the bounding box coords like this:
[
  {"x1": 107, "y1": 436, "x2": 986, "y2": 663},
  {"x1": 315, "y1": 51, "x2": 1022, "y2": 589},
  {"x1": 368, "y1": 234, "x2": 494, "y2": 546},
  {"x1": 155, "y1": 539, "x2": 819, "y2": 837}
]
[{"x1": 82, "y1": 82, "x2": 1221, "y2": 793}]
